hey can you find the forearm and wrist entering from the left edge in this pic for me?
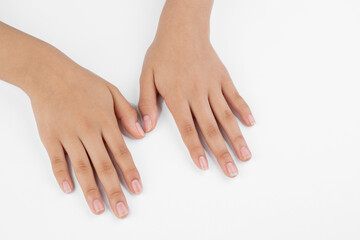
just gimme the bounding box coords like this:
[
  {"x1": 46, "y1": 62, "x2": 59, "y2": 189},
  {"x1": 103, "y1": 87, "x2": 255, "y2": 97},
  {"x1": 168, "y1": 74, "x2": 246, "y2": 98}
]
[{"x1": 0, "y1": 22, "x2": 76, "y2": 94}]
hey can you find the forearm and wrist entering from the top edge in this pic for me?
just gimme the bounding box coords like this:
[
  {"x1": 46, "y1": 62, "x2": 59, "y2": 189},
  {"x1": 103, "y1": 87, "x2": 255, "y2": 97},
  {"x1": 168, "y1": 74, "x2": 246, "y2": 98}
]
[{"x1": 157, "y1": 0, "x2": 214, "y2": 41}]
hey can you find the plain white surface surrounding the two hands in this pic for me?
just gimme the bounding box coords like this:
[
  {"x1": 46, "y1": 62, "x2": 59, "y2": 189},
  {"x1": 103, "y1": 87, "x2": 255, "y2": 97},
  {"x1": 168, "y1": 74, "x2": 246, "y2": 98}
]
[{"x1": 0, "y1": 0, "x2": 360, "y2": 240}]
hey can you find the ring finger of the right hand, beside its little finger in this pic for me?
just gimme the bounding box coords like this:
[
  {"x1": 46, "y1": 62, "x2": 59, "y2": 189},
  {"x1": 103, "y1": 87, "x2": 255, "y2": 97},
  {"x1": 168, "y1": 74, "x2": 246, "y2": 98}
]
[{"x1": 209, "y1": 92, "x2": 251, "y2": 161}]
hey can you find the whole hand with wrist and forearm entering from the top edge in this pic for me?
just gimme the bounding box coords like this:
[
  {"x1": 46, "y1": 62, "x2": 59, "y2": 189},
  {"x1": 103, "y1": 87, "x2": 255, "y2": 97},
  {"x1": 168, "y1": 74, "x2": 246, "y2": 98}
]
[{"x1": 139, "y1": 0, "x2": 255, "y2": 177}]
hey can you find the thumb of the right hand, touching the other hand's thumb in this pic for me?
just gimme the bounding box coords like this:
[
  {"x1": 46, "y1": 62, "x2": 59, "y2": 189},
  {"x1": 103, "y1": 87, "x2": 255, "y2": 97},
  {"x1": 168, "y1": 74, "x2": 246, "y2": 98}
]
[{"x1": 139, "y1": 70, "x2": 157, "y2": 132}]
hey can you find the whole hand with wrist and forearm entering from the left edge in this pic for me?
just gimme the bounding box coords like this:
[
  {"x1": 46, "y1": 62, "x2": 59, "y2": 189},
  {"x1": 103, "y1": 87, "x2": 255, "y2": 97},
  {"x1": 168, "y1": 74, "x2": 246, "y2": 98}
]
[{"x1": 0, "y1": 22, "x2": 144, "y2": 218}]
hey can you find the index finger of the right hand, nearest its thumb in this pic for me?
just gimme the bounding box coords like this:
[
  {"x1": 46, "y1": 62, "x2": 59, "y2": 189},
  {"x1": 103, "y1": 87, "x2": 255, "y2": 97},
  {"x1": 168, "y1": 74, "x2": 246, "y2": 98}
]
[{"x1": 168, "y1": 101, "x2": 208, "y2": 170}]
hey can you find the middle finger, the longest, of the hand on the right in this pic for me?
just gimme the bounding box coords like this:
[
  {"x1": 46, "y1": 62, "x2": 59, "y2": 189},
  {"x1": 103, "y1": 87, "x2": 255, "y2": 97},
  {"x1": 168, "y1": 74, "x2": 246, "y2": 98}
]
[{"x1": 191, "y1": 100, "x2": 238, "y2": 177}]
